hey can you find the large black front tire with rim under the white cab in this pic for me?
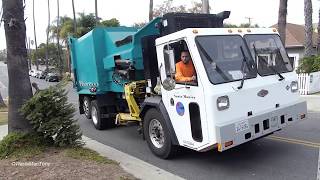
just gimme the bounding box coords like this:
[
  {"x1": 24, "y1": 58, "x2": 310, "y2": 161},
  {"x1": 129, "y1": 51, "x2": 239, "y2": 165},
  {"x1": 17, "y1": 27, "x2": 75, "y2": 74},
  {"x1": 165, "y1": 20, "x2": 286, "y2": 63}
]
[{"x1": 143, "y1": 108, "x2": 178, "y2": 159}]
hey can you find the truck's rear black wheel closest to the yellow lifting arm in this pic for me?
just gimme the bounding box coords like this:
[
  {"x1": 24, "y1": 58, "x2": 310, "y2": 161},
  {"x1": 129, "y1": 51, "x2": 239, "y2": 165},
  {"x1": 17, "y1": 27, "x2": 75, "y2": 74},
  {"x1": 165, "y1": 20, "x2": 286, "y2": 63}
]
[{"x1": 91, "y1": 100, "x2": 115, "y2": 130}]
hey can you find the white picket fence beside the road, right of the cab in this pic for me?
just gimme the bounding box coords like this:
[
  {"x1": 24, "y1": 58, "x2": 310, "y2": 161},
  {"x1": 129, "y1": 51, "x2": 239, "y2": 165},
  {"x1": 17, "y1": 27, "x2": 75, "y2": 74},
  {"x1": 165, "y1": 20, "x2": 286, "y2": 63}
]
[{"x1": 298, "y1": 72, "x2": 320, "y2": 95}]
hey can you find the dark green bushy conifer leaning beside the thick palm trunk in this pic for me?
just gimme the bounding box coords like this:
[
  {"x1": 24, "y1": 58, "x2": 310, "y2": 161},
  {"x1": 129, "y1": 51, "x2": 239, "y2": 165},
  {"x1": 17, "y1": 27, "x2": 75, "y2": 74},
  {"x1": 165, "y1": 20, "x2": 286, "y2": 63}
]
[{"x1": 21, "y1": 84, "x2": 83, "y2": 147}]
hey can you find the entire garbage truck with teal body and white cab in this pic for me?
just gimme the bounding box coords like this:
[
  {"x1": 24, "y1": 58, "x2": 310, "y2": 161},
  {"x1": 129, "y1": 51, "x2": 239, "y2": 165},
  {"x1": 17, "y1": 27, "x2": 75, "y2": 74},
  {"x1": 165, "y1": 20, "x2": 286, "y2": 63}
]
[{"x1": 68, "y1": 11, "x2": 307, "y2": 159}]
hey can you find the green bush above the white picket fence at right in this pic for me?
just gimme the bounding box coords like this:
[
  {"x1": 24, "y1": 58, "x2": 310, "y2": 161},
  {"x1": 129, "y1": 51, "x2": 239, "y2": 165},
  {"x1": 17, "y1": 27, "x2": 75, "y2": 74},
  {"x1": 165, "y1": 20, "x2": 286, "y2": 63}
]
[{"x1": 297, "y1": 56, "x2": 320, "y2": 73}]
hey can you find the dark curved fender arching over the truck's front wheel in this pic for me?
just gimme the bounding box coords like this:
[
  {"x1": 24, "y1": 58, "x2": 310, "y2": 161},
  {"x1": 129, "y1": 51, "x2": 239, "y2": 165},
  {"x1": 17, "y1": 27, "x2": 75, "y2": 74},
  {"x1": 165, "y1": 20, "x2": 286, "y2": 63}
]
[{"x1": 139, "y1": 96, "x2": 179, "y2": 145}]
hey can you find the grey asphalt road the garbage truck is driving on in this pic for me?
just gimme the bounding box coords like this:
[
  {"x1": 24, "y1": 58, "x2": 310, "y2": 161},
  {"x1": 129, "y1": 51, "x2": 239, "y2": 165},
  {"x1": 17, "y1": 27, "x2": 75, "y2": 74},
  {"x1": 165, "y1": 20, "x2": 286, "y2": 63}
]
[{"x1": 4, "y1": 74, "x2": 320, "y2": 180}]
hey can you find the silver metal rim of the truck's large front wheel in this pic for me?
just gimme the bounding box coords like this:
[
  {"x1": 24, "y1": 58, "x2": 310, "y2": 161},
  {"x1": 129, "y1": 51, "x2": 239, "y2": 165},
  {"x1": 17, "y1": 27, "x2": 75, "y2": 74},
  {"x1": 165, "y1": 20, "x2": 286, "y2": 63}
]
[{"x1": 149, "y1": 119, "x2": 164, "y2": 148}]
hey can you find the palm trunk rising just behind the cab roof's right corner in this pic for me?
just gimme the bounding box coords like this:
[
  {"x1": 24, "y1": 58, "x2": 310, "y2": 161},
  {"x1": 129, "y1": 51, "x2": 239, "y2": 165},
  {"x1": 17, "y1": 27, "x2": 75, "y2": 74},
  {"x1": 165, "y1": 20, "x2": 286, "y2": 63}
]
[{"x1": 278, "y1": 0, "x2": 288, "y2": 45}]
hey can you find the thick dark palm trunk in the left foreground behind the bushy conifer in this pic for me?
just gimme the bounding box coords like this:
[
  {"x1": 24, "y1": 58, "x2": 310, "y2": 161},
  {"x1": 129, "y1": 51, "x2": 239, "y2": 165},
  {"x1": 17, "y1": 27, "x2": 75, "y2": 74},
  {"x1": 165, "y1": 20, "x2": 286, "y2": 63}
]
[{"x1": 2, "y1": 0, "x2": 32, "y2": 132}]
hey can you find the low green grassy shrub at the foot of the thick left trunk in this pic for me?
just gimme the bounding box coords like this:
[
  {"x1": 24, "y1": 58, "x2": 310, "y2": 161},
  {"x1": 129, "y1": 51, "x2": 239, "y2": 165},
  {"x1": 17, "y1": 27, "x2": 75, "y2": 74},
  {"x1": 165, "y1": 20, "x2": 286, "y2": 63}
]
[{"x1": 0, "y1": 133, "x2": 51, "y2": 159}]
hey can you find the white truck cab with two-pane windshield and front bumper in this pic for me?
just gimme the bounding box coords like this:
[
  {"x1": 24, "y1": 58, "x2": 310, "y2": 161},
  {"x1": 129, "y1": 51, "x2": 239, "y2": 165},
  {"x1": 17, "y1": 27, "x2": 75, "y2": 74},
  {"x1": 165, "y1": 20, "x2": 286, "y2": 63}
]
[{"x1": 156, "y1": 28, "x2": 307, "y2": 151}]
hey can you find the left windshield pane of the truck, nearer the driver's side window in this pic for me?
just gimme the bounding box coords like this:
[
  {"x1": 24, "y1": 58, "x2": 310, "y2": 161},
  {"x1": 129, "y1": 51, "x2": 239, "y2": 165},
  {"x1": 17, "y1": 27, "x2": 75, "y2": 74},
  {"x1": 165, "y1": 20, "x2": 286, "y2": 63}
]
[{"x1": 196, "y1": 35, "x2": 257, "y2": 84}]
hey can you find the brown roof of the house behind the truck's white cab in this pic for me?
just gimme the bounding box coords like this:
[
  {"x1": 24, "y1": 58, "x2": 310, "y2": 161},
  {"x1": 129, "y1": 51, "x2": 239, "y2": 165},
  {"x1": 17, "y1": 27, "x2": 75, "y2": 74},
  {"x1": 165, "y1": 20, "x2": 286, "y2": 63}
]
[{"x1": 271, "y1": 23, "x2": 318, "y2": 47}]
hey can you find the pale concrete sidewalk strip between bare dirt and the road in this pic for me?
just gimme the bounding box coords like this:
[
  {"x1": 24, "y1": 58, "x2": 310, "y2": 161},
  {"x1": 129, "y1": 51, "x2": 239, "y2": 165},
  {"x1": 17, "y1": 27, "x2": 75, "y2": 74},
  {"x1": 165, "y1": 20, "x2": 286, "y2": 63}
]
[{"x1": 0, "y1": 125, "x2": 183, "y2": 180}]
